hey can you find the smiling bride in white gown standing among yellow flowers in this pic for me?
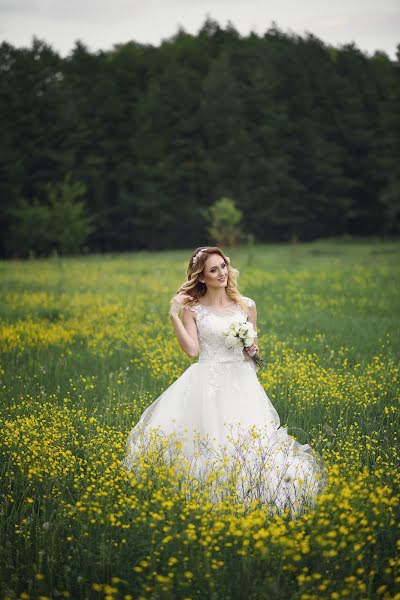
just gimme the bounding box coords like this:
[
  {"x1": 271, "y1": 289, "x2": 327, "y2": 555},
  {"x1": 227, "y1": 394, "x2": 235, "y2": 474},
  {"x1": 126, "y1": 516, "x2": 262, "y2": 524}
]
[{"x1": 123, "y1": 246, "x2": 326, "y2": 514}]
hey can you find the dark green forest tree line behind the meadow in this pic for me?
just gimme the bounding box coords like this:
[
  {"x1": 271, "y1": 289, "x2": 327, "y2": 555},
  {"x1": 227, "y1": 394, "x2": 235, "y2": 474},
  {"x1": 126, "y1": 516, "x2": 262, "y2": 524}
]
[{"x1": 0, "y1": 19, "x2": 400, "y2": 256}]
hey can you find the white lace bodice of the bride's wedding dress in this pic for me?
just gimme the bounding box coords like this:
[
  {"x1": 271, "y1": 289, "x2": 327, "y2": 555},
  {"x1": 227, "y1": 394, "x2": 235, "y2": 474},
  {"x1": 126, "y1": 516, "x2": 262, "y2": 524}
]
[{"x1": 184, "y1": 296, "x2": 254, "y2": 362}]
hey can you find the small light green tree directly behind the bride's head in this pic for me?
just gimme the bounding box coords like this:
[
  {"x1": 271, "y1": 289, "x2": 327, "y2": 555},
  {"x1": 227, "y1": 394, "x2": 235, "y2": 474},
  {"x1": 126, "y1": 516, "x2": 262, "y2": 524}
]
[{"x1": 206, "y1": 197, "x2": 243, "y2": 246}]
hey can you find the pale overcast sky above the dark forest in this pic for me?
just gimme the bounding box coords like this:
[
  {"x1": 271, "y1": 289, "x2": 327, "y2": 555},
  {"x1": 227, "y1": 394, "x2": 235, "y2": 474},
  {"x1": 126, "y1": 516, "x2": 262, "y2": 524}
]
[{"x1": 0, "y1": 0, "x2": 400, "y2": 59}]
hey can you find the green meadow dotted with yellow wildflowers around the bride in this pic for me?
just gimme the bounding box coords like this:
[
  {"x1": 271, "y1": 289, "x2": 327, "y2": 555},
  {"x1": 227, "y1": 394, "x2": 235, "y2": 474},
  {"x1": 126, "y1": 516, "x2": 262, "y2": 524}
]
[{"x1": 0, "y1": 240, "x2": 400, "y2": 600}]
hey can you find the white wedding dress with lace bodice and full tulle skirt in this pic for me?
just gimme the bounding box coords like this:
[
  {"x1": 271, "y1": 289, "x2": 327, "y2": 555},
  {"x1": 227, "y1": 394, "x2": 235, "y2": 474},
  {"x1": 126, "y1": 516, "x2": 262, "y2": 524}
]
[{"x1": 122, "y1": 296, "x2": 326, "y2": 514}]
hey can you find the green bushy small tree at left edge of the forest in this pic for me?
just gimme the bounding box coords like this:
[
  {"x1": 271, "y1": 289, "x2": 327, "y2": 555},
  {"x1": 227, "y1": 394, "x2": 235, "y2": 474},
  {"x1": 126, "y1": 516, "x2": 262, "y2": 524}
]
[{"x1": 9, "y1": 176, "x2": 93, "y2": 256}]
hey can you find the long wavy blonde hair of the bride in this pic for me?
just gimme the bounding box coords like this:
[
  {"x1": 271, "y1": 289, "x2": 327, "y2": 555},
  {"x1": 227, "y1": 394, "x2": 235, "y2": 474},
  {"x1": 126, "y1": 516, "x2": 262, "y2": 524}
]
[{"x1": 176, "y1": 246, "x2": 246, "y2": 311}]
